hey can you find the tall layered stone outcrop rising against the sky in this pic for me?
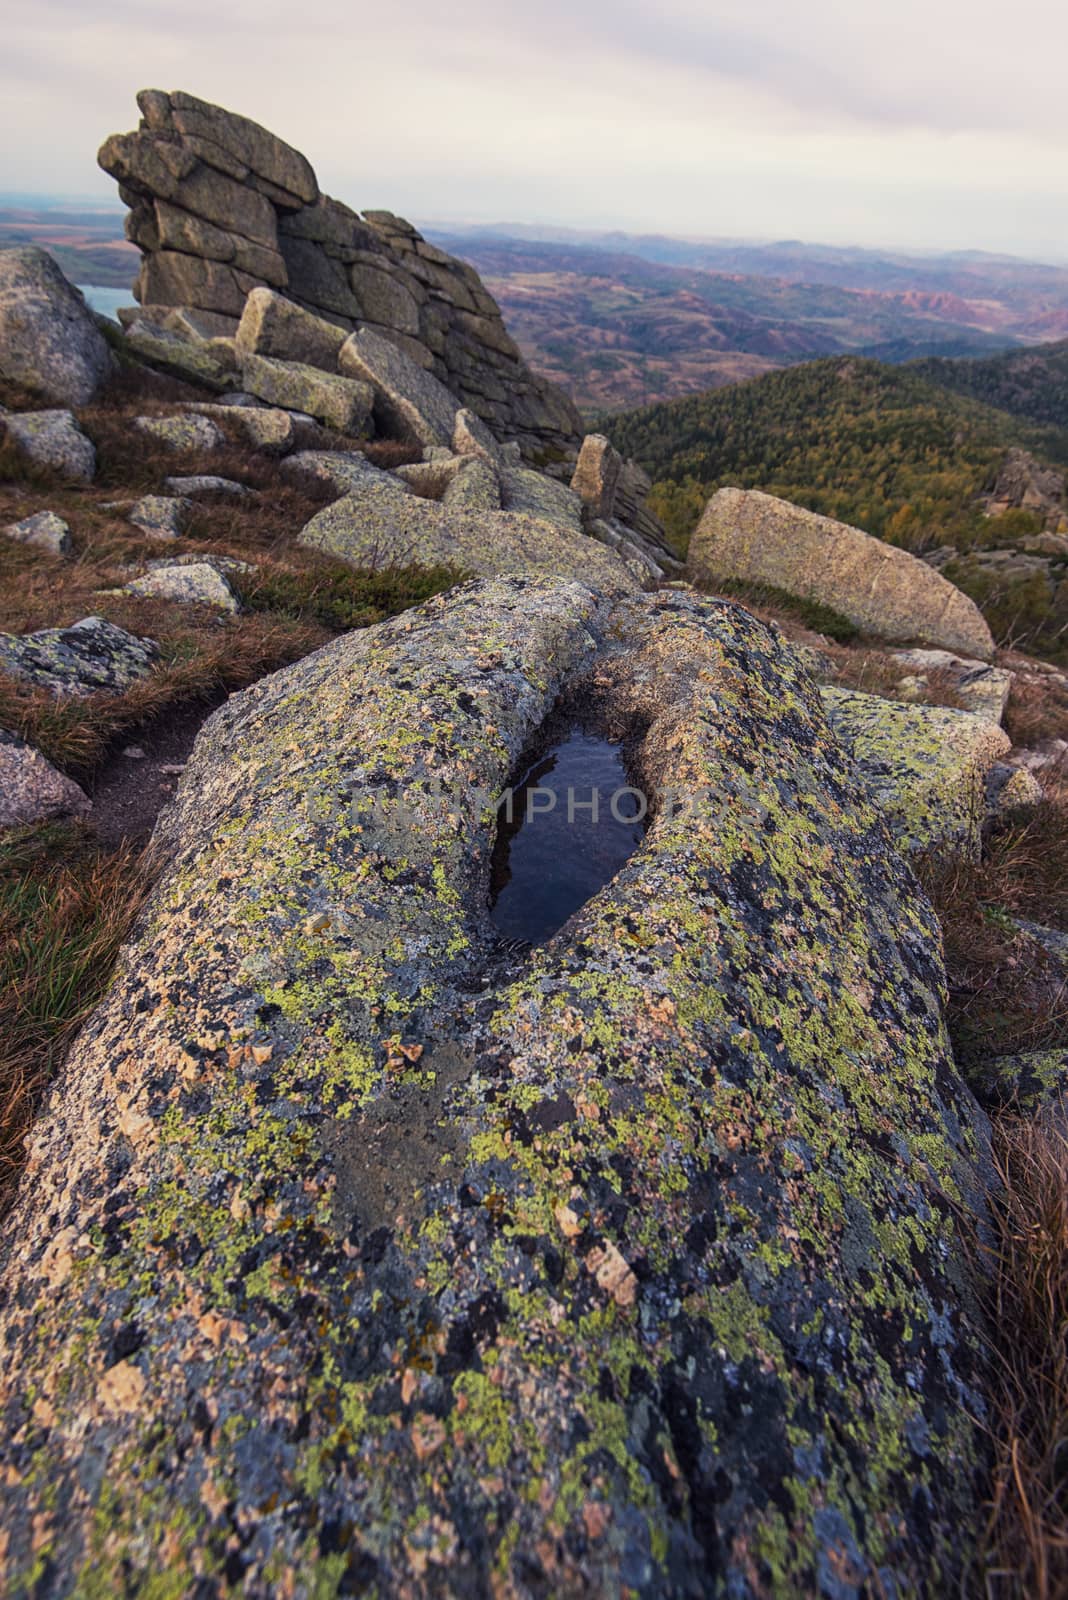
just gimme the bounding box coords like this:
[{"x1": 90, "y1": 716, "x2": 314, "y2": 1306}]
[{"x1": 99, "y1": 90, "x2": 582, "y2": 454}]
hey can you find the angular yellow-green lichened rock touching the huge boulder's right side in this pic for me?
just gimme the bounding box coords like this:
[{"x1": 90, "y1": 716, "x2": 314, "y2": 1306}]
[{"x1": 820, "y1": 685, "x2": 1009, "y2": 858}]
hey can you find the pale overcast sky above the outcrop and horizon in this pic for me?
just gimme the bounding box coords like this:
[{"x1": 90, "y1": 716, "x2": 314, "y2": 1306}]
[{"x1": 0, "y1": 0, "x2": 1068, "y2": 261}]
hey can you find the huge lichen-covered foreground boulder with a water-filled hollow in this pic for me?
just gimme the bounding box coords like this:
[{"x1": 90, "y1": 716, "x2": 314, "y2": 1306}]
[{"x1": 0, "y1": 582, "x2": 986, "y2": 1600}]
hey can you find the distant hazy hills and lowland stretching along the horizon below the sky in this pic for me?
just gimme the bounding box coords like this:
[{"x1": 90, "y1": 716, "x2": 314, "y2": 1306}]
[{"x1": 0, "y1": 197, "x2": 1068, "y2": 421}]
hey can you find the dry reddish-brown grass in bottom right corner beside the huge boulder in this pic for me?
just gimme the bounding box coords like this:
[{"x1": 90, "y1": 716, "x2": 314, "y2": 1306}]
[{"x1": 985, "y1": 1106, "x2": 1068, "y2": 1600}]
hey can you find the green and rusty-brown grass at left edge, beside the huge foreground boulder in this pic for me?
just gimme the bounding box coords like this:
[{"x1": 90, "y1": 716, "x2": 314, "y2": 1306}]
[{"x1": 0, "y1": 822, "x2": 150, "y2": 1213}]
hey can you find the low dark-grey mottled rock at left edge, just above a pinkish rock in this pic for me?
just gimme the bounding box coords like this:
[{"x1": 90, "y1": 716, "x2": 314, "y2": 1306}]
[{"x1": 0, "y1": 616, "x2": 158, "y2": 694}]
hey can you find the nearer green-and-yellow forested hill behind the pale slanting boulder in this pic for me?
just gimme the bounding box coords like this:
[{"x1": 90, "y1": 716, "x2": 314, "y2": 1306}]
[{"x1": 603, "y1": 357, "x2": 1068, "y2": 550}]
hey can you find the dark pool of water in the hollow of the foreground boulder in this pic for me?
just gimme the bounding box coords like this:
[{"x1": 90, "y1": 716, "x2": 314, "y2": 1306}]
[{"x1": 489, "y1": 730, "x2": 646, "y2": 944}]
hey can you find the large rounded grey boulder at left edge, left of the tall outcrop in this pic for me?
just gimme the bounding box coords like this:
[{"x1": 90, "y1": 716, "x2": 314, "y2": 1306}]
[{"x1": 0, "y1": 245, "x2": 114, "y2": 405}]
